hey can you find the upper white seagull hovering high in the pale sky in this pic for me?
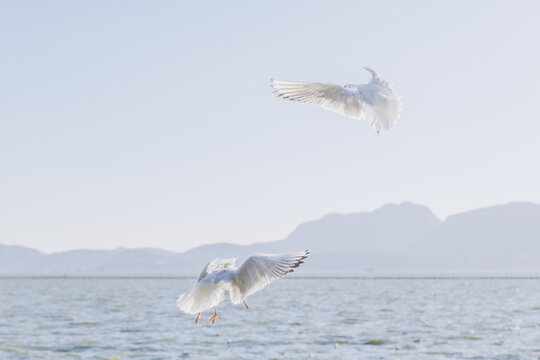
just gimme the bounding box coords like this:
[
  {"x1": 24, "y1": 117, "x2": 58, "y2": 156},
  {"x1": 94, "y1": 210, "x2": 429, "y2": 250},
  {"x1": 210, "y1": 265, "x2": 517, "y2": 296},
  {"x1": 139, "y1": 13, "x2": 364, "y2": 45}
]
[{"x1": 271, "y1": 66, "x2": 402, "y2": 135}]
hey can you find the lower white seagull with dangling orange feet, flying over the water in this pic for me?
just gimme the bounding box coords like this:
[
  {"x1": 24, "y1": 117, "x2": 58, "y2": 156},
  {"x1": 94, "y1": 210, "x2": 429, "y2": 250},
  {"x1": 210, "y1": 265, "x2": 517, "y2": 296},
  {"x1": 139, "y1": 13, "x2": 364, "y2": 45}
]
[{"x1": 176, "y1": 250, "x2": 309, "y2": 325}]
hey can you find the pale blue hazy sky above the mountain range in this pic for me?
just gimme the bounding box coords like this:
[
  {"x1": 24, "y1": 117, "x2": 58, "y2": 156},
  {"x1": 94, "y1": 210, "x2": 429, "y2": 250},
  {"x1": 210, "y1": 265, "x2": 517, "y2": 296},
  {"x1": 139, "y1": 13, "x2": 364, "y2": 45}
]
[{"x1": 0, "y1": 1, "x2": 540, "y2": 252}]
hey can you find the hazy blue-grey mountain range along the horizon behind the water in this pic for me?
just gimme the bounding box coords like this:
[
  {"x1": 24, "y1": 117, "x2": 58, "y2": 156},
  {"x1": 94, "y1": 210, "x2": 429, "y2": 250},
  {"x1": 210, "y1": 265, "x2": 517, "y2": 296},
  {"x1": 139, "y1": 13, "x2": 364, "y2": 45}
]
[{"x1": 0, "y1": 202, "x2": 540, "y2": 275}]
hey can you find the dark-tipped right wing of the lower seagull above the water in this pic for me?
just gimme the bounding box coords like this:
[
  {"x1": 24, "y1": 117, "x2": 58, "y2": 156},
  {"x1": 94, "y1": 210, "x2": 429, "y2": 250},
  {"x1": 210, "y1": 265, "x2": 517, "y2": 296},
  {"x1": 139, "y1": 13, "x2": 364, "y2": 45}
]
[{"x1": 230, "y1": 250, "x2": 309, "y2": 304}]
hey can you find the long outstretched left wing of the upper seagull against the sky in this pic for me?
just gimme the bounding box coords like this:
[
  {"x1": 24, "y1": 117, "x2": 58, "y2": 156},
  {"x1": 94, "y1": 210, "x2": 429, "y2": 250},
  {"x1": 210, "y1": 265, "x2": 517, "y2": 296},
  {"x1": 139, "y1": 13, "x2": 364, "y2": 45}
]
[{"x1": 272, "y1": 80, "x2": 367, "y2": 119}]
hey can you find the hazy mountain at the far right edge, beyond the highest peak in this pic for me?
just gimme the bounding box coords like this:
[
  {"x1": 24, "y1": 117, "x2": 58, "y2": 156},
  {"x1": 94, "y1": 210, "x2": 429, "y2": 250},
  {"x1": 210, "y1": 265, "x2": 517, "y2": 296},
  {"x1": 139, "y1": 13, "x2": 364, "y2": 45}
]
[{"x1": 406, "y1": 203, "x2": 540, "y2": 271}]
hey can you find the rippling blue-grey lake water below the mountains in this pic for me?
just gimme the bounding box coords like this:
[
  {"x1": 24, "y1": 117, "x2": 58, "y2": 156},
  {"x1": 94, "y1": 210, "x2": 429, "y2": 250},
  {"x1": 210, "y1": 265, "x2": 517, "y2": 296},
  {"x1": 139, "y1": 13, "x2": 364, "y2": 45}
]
[{"x1": 0, "y1": 277, "x2": 540, "y2": 360}]
